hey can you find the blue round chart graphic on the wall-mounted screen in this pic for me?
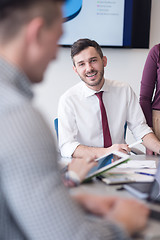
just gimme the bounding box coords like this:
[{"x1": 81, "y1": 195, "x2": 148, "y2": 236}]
[{"x1": 63, "y1": 0, "x2": 82, "y2": 22}]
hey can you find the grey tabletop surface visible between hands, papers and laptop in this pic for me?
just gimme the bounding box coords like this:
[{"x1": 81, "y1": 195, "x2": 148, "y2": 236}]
[{"x1": 72, "y1": 155, "x2": 160, "y2": 240}]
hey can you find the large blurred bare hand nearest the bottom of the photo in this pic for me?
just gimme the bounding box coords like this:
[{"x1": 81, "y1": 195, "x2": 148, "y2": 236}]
[{"x1": 73, "y1": 193, "x2": 149, "y2": 235}]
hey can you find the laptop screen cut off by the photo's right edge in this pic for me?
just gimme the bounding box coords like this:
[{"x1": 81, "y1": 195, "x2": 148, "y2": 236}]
[{"x1": 149, "y1": 161, "x2": 160, "y2": 202}]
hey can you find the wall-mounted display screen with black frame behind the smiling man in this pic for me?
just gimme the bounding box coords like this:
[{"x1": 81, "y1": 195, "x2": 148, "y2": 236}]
[{"x1": 59, "y1": 0, "x2": 151, "y2": 48}]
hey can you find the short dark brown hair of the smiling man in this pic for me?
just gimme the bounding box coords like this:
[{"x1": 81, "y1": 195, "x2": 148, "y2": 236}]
[{"x1": 71, "y1": 38, "x2": 103, "y2": 63}]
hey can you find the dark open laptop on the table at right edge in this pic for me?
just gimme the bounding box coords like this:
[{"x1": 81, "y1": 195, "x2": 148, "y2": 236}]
[{"x1": 123, "y1": 161, "x2": 160, "y2": 220}]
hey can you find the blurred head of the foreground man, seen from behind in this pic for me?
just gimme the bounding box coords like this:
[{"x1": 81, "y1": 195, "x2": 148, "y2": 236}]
[{"x1": 0, "y1": 0, "x2": 65, "y2": 82}]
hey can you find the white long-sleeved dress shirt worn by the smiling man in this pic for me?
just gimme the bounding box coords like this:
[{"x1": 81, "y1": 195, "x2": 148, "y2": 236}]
[{"x1": 58, "y1": 80, "x2": 152, "y2": 157}]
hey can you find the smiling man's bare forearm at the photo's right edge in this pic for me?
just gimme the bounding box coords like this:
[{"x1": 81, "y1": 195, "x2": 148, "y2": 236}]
[{"x1": 143, "y1": 133, "x2": 160, "y2": 154}]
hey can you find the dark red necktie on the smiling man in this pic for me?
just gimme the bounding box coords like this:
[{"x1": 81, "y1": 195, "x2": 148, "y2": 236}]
[{"x1": 95, "y1": 91, "x2": 112, "y2": 147}]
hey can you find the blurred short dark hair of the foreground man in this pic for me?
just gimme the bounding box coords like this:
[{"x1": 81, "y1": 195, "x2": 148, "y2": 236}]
[{"x1": 0, "y1": 0, "x2": 65, "y2": 41}]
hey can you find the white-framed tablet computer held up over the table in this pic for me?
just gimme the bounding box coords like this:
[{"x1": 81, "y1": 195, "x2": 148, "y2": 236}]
[{"x1": 84, "y1": 151, "x2": 129, "y2": 181}]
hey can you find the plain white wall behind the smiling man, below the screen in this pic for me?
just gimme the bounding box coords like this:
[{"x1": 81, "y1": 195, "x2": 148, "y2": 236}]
[{"x1": 32, "y1": 0, "x2": 160, "y2": 149}]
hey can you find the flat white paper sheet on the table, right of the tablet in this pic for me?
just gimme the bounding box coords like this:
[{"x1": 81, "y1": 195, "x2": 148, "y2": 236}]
[{"x1": 117, "y1": 160, "x2": 156, "y2": 168}]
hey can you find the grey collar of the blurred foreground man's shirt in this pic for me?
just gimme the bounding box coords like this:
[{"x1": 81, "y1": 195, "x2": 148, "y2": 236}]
[{"x1": 0, "y1": 58, "x2": 33, "y2": 98}]
